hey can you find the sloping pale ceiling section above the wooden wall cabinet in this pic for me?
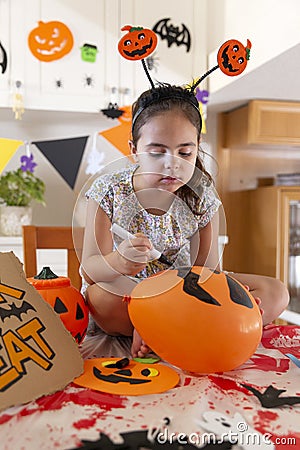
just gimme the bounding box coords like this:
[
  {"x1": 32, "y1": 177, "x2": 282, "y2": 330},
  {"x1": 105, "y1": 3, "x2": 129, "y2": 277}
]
[{"x1": 207, "y1": 44, "x2": 300, "y2": 112}]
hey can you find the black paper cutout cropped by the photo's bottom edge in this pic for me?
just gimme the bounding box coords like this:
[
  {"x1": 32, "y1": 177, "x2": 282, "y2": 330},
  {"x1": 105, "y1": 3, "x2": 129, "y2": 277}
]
[{"x1": 69, "y1": 430, "x2": 233, "y2": 450}]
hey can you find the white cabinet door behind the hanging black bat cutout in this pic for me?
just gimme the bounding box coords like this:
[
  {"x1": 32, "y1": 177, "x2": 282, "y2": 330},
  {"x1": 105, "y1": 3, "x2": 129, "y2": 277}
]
[{"x1": 120, "y1": 0, "x2": 206, "y2": 100}]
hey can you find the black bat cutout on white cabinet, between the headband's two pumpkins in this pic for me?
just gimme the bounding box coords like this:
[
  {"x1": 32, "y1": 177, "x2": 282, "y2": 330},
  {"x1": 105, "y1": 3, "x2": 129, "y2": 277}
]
[{"x1": 152, "y1": 17, "x2": 191, "y2": 52}]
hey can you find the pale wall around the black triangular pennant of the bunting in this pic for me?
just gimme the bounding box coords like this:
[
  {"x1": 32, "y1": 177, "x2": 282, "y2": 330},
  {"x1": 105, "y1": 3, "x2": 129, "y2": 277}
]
[{"x1": 0, "y1": 108, "x2": 122, "y2": 225}]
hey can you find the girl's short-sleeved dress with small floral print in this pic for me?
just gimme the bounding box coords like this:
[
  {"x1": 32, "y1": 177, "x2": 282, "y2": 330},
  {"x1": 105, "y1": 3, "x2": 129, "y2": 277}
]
[{"x1": 86, "y1": 164, "x2": 221, "y2": 278}]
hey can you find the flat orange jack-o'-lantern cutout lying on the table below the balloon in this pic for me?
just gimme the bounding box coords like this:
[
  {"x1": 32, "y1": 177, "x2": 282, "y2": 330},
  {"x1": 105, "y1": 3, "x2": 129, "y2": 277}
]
[{"x1": 74, "y1": 358, "x2": 179, "y2": 395}]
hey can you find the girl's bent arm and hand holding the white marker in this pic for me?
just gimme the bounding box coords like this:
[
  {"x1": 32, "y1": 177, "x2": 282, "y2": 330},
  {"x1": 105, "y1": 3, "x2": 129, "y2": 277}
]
[{"x1": 81, "y1": 199, "x2": 151, "y2": 284}]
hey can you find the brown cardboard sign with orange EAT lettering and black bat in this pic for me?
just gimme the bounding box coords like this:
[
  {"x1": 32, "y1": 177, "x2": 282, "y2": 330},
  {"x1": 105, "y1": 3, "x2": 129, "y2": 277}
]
[{"x1": 0, "y1": 252, "x2": 83, "y2": 409}]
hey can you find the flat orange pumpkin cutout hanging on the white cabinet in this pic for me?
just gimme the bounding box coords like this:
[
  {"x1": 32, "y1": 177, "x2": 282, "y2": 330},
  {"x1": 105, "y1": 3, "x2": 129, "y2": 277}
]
[{"x1": 28, "y1": 21, "x2": 74, "y2": 62}]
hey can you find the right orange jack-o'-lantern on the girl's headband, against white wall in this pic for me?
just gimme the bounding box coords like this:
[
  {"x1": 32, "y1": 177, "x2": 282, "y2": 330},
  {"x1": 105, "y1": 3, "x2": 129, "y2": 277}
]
[{"x1": 217, "y1": 39, "x2": 251, "y2": 77}]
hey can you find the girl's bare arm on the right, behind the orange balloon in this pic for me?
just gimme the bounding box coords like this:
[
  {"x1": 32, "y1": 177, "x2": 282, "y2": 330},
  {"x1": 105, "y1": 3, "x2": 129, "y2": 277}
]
[{"x1": 191, "y1": 212, "x2": 220, "y2": 270}]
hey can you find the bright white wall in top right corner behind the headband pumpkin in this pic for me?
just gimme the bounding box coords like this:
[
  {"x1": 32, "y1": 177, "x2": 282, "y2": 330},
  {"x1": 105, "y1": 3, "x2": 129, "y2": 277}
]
[{"x1": 207, "y1": 0, "x2": 300, "y2": 92}]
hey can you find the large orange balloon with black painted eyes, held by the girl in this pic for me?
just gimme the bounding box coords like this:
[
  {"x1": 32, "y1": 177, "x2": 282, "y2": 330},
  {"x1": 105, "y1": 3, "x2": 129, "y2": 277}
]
[{"x1": 128, "y1": 266, "x2": 262, "y2": 373}]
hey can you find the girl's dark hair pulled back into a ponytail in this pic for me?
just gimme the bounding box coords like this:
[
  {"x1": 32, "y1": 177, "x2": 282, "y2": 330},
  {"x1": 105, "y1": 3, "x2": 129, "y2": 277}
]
[{"x1": 132, "y1": 84, "x2": 213, "y2": 218}]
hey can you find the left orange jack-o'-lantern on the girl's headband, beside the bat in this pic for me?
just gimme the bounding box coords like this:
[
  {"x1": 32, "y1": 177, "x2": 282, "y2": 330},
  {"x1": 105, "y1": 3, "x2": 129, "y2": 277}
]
[{"x1": 118, "y1": 25, "x2": 157, "y2": 61}]
